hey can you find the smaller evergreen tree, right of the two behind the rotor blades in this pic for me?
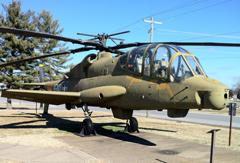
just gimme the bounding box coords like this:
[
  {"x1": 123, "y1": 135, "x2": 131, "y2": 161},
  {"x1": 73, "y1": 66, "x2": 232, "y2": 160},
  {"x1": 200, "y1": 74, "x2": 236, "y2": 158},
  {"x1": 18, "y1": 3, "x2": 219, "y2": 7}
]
[{"x1": 35, "y1": 10, "x2": 71, "y2": 80}]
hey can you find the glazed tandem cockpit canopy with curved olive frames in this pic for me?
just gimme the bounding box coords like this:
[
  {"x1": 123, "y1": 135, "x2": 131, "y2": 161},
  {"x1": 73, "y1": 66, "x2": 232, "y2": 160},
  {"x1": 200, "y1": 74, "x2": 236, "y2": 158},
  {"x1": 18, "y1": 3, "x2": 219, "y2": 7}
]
[{"x1": 120, "y1": 44, "x2": 206, "y2": 83}]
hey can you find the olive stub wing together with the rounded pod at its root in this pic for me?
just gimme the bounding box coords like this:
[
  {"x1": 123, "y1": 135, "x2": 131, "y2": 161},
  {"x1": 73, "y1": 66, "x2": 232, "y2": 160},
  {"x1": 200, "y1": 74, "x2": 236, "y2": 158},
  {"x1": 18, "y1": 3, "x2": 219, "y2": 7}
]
[{"x1": 1, "y1": 86, "x2": 126, "y2": 105}]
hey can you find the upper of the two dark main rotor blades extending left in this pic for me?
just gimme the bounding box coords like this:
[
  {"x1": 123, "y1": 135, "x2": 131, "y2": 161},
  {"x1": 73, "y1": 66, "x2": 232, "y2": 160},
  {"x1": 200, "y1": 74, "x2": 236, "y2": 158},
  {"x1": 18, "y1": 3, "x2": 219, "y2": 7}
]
[{"x1": 0, "y1": 26, "x2": 100, "y2": 47}]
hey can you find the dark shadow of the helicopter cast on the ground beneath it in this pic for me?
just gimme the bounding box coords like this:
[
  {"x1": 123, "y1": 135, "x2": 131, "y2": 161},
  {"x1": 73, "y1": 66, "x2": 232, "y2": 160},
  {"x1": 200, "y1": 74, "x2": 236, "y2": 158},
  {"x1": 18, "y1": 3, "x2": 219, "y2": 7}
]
[{"x1": 0, "y1": 113, "x2": 176, "y2": 146}]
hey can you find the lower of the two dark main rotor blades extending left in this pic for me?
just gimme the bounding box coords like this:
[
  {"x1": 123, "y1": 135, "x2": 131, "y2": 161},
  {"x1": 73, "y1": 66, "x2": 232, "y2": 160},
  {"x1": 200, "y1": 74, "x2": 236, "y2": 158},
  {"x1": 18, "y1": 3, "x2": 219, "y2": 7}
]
[{"x1": 0, "y1": 47, "x2": 95, "y2": 67}]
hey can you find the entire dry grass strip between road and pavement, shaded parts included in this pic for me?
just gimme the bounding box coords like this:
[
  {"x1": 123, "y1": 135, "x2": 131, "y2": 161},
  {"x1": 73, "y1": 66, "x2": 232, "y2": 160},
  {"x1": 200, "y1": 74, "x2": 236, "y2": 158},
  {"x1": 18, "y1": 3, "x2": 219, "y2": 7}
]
[{"x1": 0, "y1": 109, "x2": 240, "y2": 151}]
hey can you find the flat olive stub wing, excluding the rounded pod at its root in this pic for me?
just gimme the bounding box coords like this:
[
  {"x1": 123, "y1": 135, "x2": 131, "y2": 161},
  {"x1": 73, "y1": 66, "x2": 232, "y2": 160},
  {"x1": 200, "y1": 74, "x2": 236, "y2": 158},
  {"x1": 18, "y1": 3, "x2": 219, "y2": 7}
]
[{"x1": 1, "y1": 89, "x2": 80, "y2": 105}]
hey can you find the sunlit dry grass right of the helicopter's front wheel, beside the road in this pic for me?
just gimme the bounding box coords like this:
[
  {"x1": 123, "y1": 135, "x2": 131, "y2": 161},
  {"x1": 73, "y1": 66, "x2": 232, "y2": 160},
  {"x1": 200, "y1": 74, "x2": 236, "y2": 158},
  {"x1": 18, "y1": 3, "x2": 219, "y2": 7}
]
[{"x1": 139, "y1": 117, "x2": 240, "y2": 151}]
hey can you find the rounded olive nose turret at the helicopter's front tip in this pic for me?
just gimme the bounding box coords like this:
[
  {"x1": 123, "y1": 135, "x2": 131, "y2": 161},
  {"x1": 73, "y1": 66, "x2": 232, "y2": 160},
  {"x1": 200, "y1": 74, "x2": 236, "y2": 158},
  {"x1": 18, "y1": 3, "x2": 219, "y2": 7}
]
[{"x1": 203, "y1": 87, "x2": 229, "y2": 110}]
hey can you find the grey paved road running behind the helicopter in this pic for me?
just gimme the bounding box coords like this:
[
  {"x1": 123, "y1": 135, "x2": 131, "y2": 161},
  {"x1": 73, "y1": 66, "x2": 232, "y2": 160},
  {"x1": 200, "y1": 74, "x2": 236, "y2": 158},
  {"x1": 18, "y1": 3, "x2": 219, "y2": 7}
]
[{"x1": 0, "y1": 98, "x2": 240, "y2": 128}]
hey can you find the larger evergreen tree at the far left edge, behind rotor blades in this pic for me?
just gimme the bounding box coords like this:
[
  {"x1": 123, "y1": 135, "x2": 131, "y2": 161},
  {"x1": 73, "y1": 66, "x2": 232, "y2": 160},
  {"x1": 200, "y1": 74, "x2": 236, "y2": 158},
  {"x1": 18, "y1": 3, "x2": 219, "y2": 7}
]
[{"x1": 0, "y1": 1, "x2": 36, "y2": 108}]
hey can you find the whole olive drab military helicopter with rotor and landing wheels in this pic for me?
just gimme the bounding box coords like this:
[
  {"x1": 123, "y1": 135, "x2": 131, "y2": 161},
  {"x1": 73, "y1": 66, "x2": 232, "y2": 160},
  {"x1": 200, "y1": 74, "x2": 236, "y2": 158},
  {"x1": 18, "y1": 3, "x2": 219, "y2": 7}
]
[{"x1": 0, "y1": 27, "x2": 240, "y2": 135}]
